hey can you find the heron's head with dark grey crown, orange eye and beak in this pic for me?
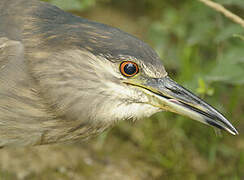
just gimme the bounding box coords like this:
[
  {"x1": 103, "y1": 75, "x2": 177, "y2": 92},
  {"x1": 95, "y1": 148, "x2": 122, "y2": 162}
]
[{"x1": 27, "y1": 4, "x2": 238, "y2": 135}]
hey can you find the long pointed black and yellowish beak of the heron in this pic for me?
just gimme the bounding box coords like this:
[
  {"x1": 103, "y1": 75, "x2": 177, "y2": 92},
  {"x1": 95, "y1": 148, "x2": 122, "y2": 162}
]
[{"x1": 124, "y1": 76, "x2": 238, "y2": 135}]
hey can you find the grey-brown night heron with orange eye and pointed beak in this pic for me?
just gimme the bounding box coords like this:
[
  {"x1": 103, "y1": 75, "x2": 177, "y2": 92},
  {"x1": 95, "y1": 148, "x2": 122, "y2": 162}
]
[{"x1": 0, "y1": 0, "x2": 238, "y2": 146}]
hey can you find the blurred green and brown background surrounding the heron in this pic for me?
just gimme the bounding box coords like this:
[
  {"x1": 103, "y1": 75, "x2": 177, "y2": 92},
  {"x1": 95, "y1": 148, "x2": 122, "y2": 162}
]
[{"x1": 0, "y1": 0, "x2": 244, "y2": 180}]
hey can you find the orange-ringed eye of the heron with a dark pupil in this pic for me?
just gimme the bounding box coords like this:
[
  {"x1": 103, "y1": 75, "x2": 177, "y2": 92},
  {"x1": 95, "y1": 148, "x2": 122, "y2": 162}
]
[{"x1": 120, "y1": 61, "x2": 139, "y2": 77}]
